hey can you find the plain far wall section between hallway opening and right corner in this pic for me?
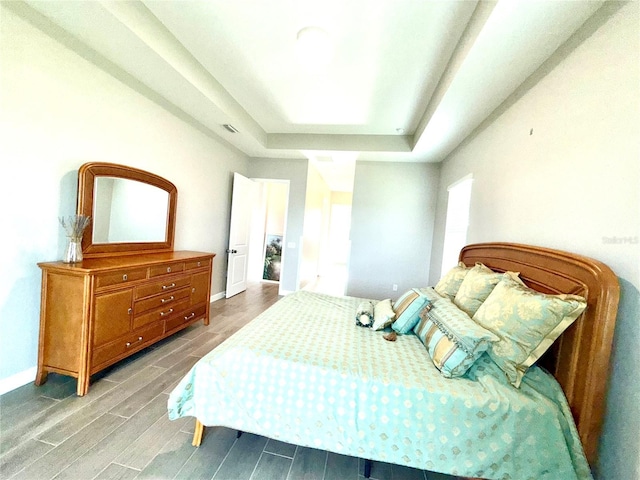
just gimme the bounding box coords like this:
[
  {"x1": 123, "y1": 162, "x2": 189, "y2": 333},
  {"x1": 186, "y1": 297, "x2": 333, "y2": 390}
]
[{"x1": 347, "y1": 162, "x2": 439, "y2": 299}]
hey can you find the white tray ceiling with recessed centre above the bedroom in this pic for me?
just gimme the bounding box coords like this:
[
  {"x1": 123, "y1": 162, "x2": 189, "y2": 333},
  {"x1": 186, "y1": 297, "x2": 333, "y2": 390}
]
[{"x1": 21, "y1": 0, "x2": 603, "y2": 190}]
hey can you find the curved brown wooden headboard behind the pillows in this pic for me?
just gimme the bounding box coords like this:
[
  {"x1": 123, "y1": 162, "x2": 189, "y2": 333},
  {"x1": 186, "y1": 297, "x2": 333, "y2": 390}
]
[{"x1": 460, "y1": 243, "x2": 620, "y2": 465}]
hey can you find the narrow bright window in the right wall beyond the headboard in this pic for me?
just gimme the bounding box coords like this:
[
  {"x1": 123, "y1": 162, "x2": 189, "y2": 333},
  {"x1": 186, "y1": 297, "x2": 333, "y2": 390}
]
[{"x1": 441, "y1": 174, "x2": 473, "y2": 275}]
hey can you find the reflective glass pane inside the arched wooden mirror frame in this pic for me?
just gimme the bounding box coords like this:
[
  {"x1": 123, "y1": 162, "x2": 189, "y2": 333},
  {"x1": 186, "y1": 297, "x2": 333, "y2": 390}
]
[{"x1": 93, "y1": 177, "x2": 169, "y2": 244}]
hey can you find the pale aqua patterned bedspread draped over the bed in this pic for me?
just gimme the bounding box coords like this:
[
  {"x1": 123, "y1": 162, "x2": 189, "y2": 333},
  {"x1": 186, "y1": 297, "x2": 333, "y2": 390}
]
[{"x1": 168, "y1": 291, "x2": 591, "y2": 480}]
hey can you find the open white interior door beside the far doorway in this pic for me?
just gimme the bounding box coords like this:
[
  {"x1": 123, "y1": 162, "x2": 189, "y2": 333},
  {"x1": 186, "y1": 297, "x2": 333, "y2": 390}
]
[{"x1": 226, "y1": 173, "x2": 257, "y2": 298}]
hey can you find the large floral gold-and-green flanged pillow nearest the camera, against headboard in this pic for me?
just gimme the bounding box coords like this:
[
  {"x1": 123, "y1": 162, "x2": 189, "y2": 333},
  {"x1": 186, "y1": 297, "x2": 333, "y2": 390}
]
[{"x1": 473, "y1": 274, "x2": 587, "y2": 387}]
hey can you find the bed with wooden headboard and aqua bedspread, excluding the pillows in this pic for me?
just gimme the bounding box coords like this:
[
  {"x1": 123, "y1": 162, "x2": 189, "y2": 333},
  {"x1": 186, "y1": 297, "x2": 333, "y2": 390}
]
[{"x1": 168, "y1": 243, "x2": 619, "y2": 479}]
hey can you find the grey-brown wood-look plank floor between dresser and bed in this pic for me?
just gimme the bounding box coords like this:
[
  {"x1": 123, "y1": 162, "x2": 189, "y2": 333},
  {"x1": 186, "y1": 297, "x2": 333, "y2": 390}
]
[{"x1": 0, "y1": 284, "x2": 455, "y2": 480}]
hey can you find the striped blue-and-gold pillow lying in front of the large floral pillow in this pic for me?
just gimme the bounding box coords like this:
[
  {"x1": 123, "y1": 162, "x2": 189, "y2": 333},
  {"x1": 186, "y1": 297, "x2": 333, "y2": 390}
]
[{"x1": 413, "y1": 298, "x2": 498, "y2": 378}]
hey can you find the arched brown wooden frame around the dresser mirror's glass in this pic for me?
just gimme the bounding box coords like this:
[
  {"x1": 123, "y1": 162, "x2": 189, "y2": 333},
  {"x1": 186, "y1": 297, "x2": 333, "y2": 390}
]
[{"x1": 77, "y1": 162, "x2": 178, "y2": 258}]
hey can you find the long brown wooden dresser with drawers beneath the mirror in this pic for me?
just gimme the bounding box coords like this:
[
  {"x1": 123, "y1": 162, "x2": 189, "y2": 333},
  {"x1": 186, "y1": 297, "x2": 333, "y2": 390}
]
[{"x1": 36, "y1": 251, "x2": 215, "y2": 395}]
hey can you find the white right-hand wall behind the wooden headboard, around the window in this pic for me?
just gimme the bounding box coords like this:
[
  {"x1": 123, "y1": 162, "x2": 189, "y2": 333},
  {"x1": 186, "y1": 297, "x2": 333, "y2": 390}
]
[{"x1": 430, "y1": 2, "x2": 640, "y2": 480}]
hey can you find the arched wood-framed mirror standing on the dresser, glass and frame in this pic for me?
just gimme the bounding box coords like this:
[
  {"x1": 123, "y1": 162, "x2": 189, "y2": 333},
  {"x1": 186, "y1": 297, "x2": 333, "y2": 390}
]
[{"x1": 78, "y1": 163, "x2": 178, "y2": 258}]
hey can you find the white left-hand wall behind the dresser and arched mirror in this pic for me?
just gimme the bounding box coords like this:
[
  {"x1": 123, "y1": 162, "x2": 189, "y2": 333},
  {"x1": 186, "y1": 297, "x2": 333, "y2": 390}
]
[{"x1": 0, "y1": 2, "x2": 248, "y2": 385}]
